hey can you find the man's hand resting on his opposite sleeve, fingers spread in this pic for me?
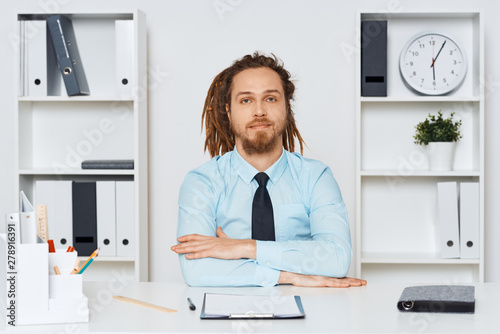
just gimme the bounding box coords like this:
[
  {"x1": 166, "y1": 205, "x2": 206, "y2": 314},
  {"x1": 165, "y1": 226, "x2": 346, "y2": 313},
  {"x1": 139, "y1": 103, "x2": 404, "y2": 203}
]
[{"x1": 171, "y1": 226, "x2": 256, "y2": 260}]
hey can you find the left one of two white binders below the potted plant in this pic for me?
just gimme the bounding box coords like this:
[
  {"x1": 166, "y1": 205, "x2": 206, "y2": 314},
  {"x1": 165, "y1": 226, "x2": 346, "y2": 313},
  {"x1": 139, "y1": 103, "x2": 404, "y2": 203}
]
[{"x1": 437, "y1": 182, "x2": 460, "y2": 258}]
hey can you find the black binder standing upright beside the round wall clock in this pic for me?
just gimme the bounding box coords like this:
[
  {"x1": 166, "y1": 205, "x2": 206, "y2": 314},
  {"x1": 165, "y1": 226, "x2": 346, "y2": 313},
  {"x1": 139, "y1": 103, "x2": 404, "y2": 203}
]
[{"x1": 361, "y1": 20, "x2": 387, "y2": 96}]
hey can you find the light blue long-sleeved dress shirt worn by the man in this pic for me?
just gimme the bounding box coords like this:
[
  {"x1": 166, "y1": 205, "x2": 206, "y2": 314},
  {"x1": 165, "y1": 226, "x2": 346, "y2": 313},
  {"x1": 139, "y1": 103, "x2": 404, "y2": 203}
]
[{"x1": 177, "y1": 149, "x2": 352, "y2": 286}]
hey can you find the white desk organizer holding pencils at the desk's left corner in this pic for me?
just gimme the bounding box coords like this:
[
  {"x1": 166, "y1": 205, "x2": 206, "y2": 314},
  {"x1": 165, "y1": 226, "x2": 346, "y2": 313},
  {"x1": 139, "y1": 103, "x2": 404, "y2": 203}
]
[{"x1": 10, "y1": 243, "x2": 89, "y2": 325}]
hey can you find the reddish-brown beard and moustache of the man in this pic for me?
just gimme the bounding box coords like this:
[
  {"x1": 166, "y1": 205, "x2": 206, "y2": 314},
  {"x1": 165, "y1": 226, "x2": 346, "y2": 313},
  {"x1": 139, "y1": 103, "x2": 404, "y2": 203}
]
[{"x1": 231, "y1": 118, "x2": 287, "y2": 155}]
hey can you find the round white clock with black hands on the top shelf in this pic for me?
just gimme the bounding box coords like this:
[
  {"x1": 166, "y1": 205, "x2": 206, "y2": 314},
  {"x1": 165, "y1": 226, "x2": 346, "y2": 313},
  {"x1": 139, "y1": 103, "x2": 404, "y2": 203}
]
[{"x1": 399, "y1": 32, "x2": 467, "y2": 95}]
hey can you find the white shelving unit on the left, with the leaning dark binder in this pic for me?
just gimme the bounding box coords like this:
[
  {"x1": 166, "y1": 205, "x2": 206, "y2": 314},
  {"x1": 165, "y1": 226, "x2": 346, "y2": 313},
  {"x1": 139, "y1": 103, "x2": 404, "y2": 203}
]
[{"x1": 15, "y1": 10, "x2": 148, "y2": 281}]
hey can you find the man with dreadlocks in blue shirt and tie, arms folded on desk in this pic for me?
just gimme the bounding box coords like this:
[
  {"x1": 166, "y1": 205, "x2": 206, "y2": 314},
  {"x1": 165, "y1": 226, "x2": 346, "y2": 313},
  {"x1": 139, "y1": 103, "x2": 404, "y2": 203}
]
[{"x1": 172, "y1": 52, "x2": 366, "y2": 287}]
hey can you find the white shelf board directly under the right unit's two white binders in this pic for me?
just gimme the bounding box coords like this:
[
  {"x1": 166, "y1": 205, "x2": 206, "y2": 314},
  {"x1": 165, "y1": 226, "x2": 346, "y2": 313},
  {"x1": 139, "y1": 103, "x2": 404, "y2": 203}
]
[{"x1": 361, "y1": 252, "x2": 479, "y2": 264}]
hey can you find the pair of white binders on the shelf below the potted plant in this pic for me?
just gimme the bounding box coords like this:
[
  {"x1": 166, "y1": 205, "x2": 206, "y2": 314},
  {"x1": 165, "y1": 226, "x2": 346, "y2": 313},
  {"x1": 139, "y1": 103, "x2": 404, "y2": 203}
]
[{"x1": 437, "y1": 182, "x2": 479, "y2": 259}]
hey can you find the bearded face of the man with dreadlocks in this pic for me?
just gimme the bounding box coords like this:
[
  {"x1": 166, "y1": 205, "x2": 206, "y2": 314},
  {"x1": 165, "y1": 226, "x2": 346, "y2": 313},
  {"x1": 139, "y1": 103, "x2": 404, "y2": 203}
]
[{"x1": 226, "y1": 67, "x2": 287, "y2": 155}]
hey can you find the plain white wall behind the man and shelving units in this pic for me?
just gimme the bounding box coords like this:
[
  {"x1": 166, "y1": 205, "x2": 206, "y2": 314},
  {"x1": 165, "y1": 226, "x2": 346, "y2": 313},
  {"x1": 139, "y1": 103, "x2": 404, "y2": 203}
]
[{"x1": 0, "y1": 0, "x2": 500, "y2": 281}]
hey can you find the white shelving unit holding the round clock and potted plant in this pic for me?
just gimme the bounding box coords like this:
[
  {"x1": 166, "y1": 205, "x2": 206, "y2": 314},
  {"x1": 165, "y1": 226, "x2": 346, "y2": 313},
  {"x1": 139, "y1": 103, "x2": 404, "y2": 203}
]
[{"x1": 356, "y1": 11, "x2": 484, "y2": 283}]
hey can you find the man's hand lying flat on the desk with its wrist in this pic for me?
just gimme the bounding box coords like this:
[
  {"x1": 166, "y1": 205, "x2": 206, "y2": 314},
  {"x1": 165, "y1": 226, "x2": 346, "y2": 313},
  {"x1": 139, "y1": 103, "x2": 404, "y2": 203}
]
[{"x1": 278, "y1": 271, "x2": 366, "y2": 288}]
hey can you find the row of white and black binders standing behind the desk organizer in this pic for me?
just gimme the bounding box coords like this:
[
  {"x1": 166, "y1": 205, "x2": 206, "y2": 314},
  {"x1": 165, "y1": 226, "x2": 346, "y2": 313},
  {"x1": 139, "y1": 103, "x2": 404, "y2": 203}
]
[{"x1": 35, "y1": 180, "x2": 135, "y2": 257}]
